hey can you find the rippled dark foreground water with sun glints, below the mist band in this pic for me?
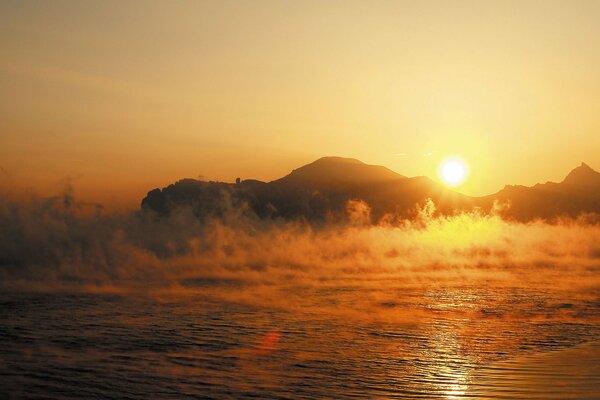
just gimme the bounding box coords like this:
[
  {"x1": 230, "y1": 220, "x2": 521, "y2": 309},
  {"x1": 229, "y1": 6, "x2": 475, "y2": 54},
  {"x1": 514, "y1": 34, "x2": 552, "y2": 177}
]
[{"x1": 0, "y1": 282, "x2": 600, "y2": 399}]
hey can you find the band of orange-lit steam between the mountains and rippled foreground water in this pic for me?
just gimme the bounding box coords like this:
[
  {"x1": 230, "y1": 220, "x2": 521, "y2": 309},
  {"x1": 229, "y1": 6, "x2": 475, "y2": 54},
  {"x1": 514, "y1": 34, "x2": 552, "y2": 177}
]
[{"x1": 0, "y1": 195, "x2": 600, "y2": 311}]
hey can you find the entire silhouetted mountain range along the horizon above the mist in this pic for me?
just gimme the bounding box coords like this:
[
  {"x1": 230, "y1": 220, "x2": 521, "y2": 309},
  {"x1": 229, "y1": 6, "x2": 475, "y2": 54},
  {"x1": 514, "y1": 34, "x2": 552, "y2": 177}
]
[{"x1": 142, "y1": 157, "x2": 600, "y2": 224}]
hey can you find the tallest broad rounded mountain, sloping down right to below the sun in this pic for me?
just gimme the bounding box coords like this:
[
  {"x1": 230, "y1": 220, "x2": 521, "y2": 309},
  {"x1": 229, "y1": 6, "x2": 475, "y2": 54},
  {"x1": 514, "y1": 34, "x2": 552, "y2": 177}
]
[{"x1": 258, "y1": 157, "x2": 469, "y2": 221}]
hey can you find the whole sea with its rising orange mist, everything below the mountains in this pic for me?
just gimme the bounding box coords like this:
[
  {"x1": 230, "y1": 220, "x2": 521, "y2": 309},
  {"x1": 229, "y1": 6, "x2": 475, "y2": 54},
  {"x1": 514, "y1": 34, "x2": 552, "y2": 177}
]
[{"x1": 0, "y1": 195, "x2": 600, "y2": 399}]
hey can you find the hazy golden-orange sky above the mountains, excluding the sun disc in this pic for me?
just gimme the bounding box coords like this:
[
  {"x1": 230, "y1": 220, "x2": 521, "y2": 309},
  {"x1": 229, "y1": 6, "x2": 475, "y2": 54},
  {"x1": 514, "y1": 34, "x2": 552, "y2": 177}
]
[{"x1": 0, "y1": 0, "x2": 600, "y2": 204}]
